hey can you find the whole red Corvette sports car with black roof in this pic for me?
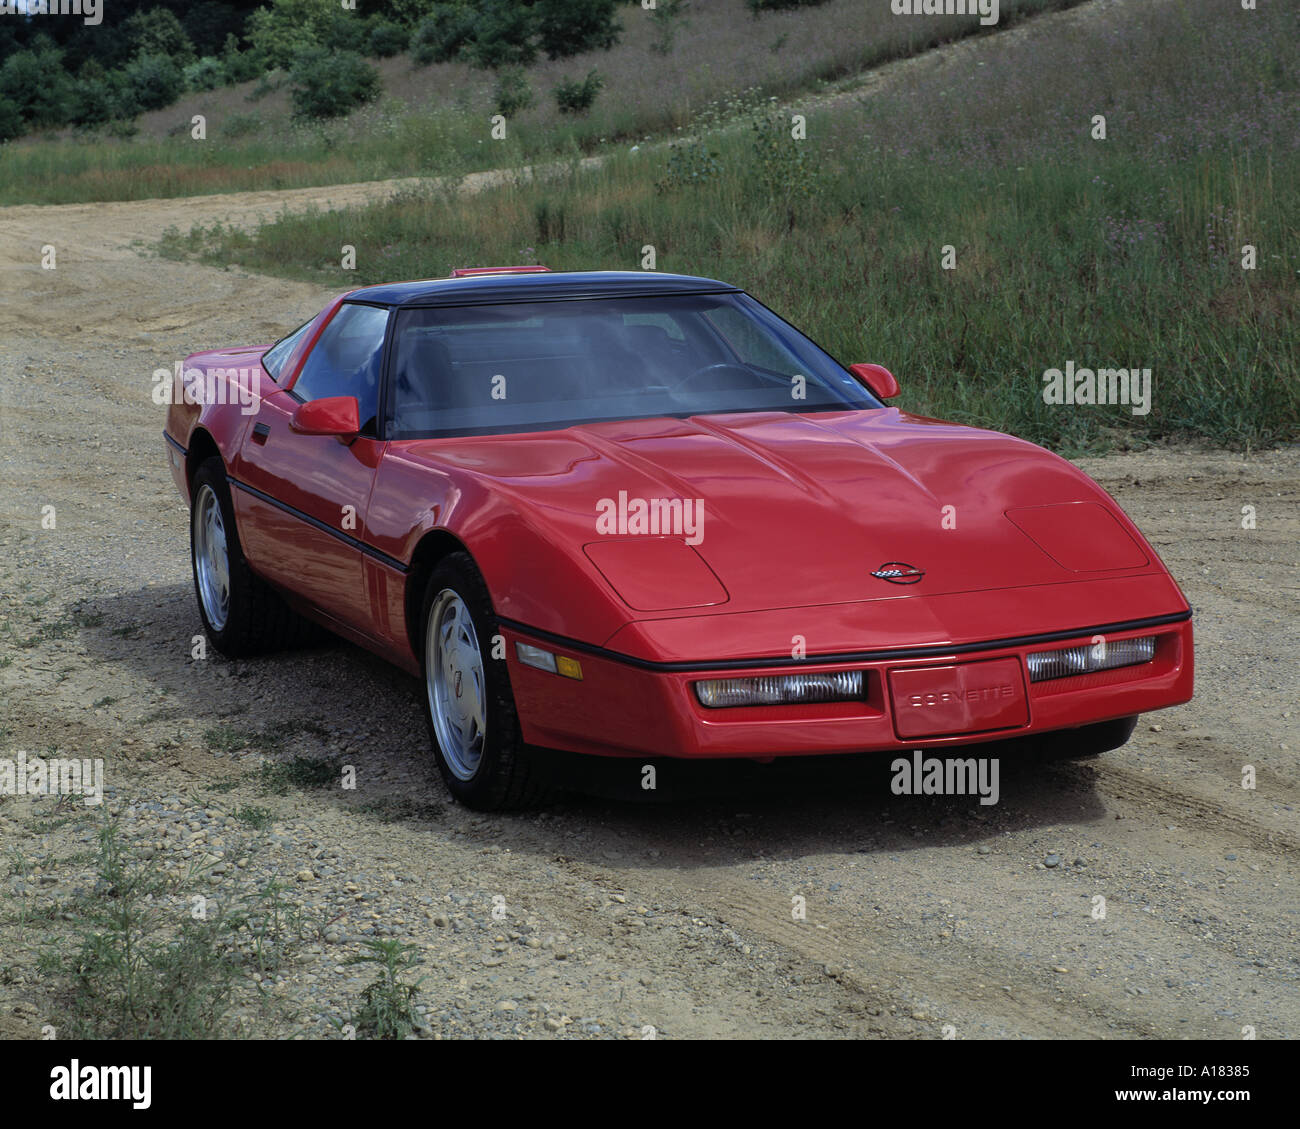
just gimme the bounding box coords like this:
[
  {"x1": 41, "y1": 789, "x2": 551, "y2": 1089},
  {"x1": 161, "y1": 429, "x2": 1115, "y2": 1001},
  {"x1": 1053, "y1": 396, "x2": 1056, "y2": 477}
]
[{"x1": 164, "y1": 267, "x2": 1193, "y2": 809}]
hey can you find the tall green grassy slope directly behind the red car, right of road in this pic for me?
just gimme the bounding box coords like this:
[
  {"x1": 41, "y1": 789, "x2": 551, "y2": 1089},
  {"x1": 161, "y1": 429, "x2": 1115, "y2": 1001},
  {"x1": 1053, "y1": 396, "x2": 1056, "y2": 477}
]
[{"x1": 164, "y1": 0, "x2": 1300, "y2": 453}]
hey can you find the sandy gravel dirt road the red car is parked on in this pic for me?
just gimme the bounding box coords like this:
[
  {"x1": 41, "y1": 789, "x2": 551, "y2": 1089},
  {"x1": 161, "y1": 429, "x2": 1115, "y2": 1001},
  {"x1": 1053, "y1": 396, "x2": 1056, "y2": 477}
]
[{"x1": 0, "y1": 141, "x2": 1300, "y2": 1039}]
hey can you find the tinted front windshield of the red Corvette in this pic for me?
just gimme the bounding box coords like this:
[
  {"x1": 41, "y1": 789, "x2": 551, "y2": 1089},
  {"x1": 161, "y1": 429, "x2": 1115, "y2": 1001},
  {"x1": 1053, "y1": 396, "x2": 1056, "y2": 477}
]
[{"x1": 385, "y1": 294, "x2": 881, "y2": 440}]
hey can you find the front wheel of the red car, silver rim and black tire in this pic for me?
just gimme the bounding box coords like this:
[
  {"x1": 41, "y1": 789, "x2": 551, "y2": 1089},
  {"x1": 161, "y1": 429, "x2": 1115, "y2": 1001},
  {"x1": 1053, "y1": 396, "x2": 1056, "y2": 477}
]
[{"x1": 420, "y1": 553, "x2": 550, "y2": 812}]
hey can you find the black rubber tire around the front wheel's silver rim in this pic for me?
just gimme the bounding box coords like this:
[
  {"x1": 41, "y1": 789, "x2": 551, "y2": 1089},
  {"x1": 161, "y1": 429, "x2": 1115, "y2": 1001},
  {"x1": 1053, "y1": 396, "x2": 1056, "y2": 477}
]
[{"x1": 420, "y1": 553, "x2": 553, "y2": 812}]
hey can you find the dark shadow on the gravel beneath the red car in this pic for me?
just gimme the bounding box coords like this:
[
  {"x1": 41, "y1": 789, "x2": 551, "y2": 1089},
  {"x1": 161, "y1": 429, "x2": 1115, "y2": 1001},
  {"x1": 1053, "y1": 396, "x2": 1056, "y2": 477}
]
[{"x1": 81, "y1": 584, "x2": 1122, "y2": 868}]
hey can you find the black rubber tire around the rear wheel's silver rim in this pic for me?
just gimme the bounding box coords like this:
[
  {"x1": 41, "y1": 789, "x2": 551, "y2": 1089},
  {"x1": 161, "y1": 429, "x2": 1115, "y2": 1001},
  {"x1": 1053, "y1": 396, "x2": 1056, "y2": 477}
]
[{"x1": 190, "y1": 458, "x2": 325, "y2": 658}]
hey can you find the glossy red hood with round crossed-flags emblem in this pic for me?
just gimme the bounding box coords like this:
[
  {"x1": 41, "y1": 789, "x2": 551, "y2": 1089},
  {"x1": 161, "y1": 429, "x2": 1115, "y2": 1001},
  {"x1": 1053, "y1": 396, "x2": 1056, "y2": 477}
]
[{"x1": 403, "y1": 408, "x2": 1164, "y2": 618}]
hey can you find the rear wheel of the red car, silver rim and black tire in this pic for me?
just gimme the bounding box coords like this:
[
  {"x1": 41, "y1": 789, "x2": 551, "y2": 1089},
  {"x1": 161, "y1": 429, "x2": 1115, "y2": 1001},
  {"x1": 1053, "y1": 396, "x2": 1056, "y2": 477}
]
[{"x1": 190, "y1": 458, "x2": 324, "y2": 658}]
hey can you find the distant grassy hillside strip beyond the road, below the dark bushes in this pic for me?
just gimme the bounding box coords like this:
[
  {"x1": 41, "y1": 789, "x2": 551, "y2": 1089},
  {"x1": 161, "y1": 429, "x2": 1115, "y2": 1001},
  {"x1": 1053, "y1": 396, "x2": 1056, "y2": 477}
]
[{"x1": 0, "y1": 0, "x2": 1084, "y2": 204}]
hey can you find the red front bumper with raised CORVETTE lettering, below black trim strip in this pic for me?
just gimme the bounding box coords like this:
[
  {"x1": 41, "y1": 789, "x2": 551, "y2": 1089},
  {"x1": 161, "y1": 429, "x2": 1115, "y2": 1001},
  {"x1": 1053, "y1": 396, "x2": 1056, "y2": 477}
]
[{"x1": 503, "y1": 613, "x2": 1193, "y2": 757}]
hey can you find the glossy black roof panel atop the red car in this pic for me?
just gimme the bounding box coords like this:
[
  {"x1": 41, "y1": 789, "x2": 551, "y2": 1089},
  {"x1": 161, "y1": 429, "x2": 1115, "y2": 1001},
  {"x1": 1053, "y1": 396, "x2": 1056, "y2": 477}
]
[{"x1": 347, "y1": 271, "x2": 740, "y2": 306}]
